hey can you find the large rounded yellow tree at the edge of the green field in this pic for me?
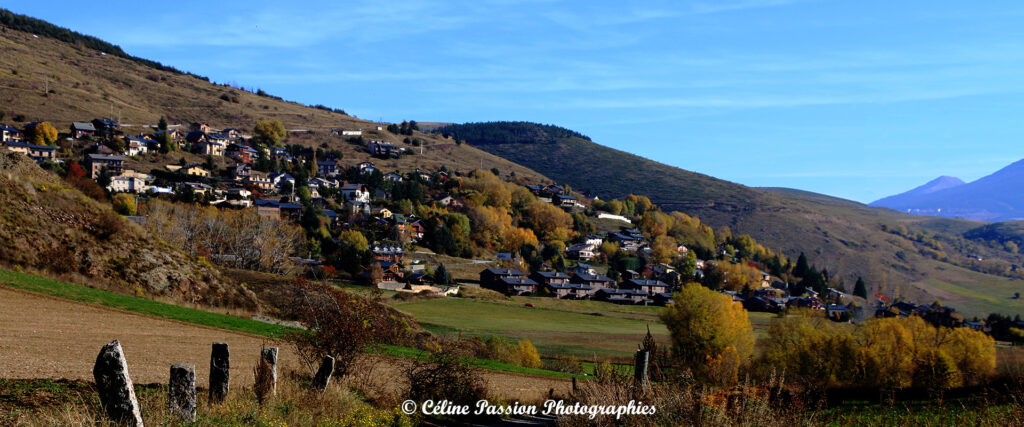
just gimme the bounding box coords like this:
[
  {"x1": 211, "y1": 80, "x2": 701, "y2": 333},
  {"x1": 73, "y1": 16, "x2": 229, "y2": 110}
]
[{"x1": 662, "y1": 284, "x2": 754, "y2": 383}]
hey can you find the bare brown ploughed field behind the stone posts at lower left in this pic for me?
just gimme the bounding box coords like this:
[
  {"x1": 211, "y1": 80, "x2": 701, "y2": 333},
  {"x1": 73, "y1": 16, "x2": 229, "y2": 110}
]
[{"x1": 0, "y1": 287, "x2": 570, "y2": 400}]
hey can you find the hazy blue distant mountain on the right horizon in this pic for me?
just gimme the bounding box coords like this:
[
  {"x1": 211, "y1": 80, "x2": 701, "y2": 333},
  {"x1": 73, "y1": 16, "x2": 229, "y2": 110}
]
[{"x1": 871, "y1": 160, "x2": 1024, "y2": 222}]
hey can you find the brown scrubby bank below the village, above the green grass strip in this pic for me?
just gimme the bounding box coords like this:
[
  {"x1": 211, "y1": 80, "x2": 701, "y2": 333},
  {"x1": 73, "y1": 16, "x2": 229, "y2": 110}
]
[{"x1": 0, "y1": 151, "x2": 257, "y2": 309}]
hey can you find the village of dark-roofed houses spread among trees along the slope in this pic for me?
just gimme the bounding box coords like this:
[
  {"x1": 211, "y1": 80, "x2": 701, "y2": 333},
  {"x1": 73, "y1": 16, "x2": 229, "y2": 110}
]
[{"x1": 0, "y1": 119, "x2": 1024, "y2": 331}]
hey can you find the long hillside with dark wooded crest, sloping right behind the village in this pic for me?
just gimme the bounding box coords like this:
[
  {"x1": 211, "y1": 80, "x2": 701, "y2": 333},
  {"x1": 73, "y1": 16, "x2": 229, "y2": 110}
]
[{"x1": 436, "y1": 122, "x2": 1024, "y2": 313}]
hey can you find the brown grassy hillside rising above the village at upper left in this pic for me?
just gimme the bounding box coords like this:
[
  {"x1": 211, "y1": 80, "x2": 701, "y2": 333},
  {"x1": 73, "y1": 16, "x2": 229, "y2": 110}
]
[{"x1": 0, "y1": 19, "x2": 547, "y2": 181}]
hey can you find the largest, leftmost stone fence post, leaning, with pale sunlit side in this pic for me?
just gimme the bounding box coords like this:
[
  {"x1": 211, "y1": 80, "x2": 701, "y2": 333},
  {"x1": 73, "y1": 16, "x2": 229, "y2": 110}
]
[{"x1": 92, "y1": 340, "x2": 142, "y2": 427}]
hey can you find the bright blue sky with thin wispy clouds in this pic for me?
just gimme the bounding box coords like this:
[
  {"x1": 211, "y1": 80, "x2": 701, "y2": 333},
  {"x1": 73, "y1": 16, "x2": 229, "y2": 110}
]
[{"x1": 3, "y1": 0, "x2": 1024, "y2": 202}]
